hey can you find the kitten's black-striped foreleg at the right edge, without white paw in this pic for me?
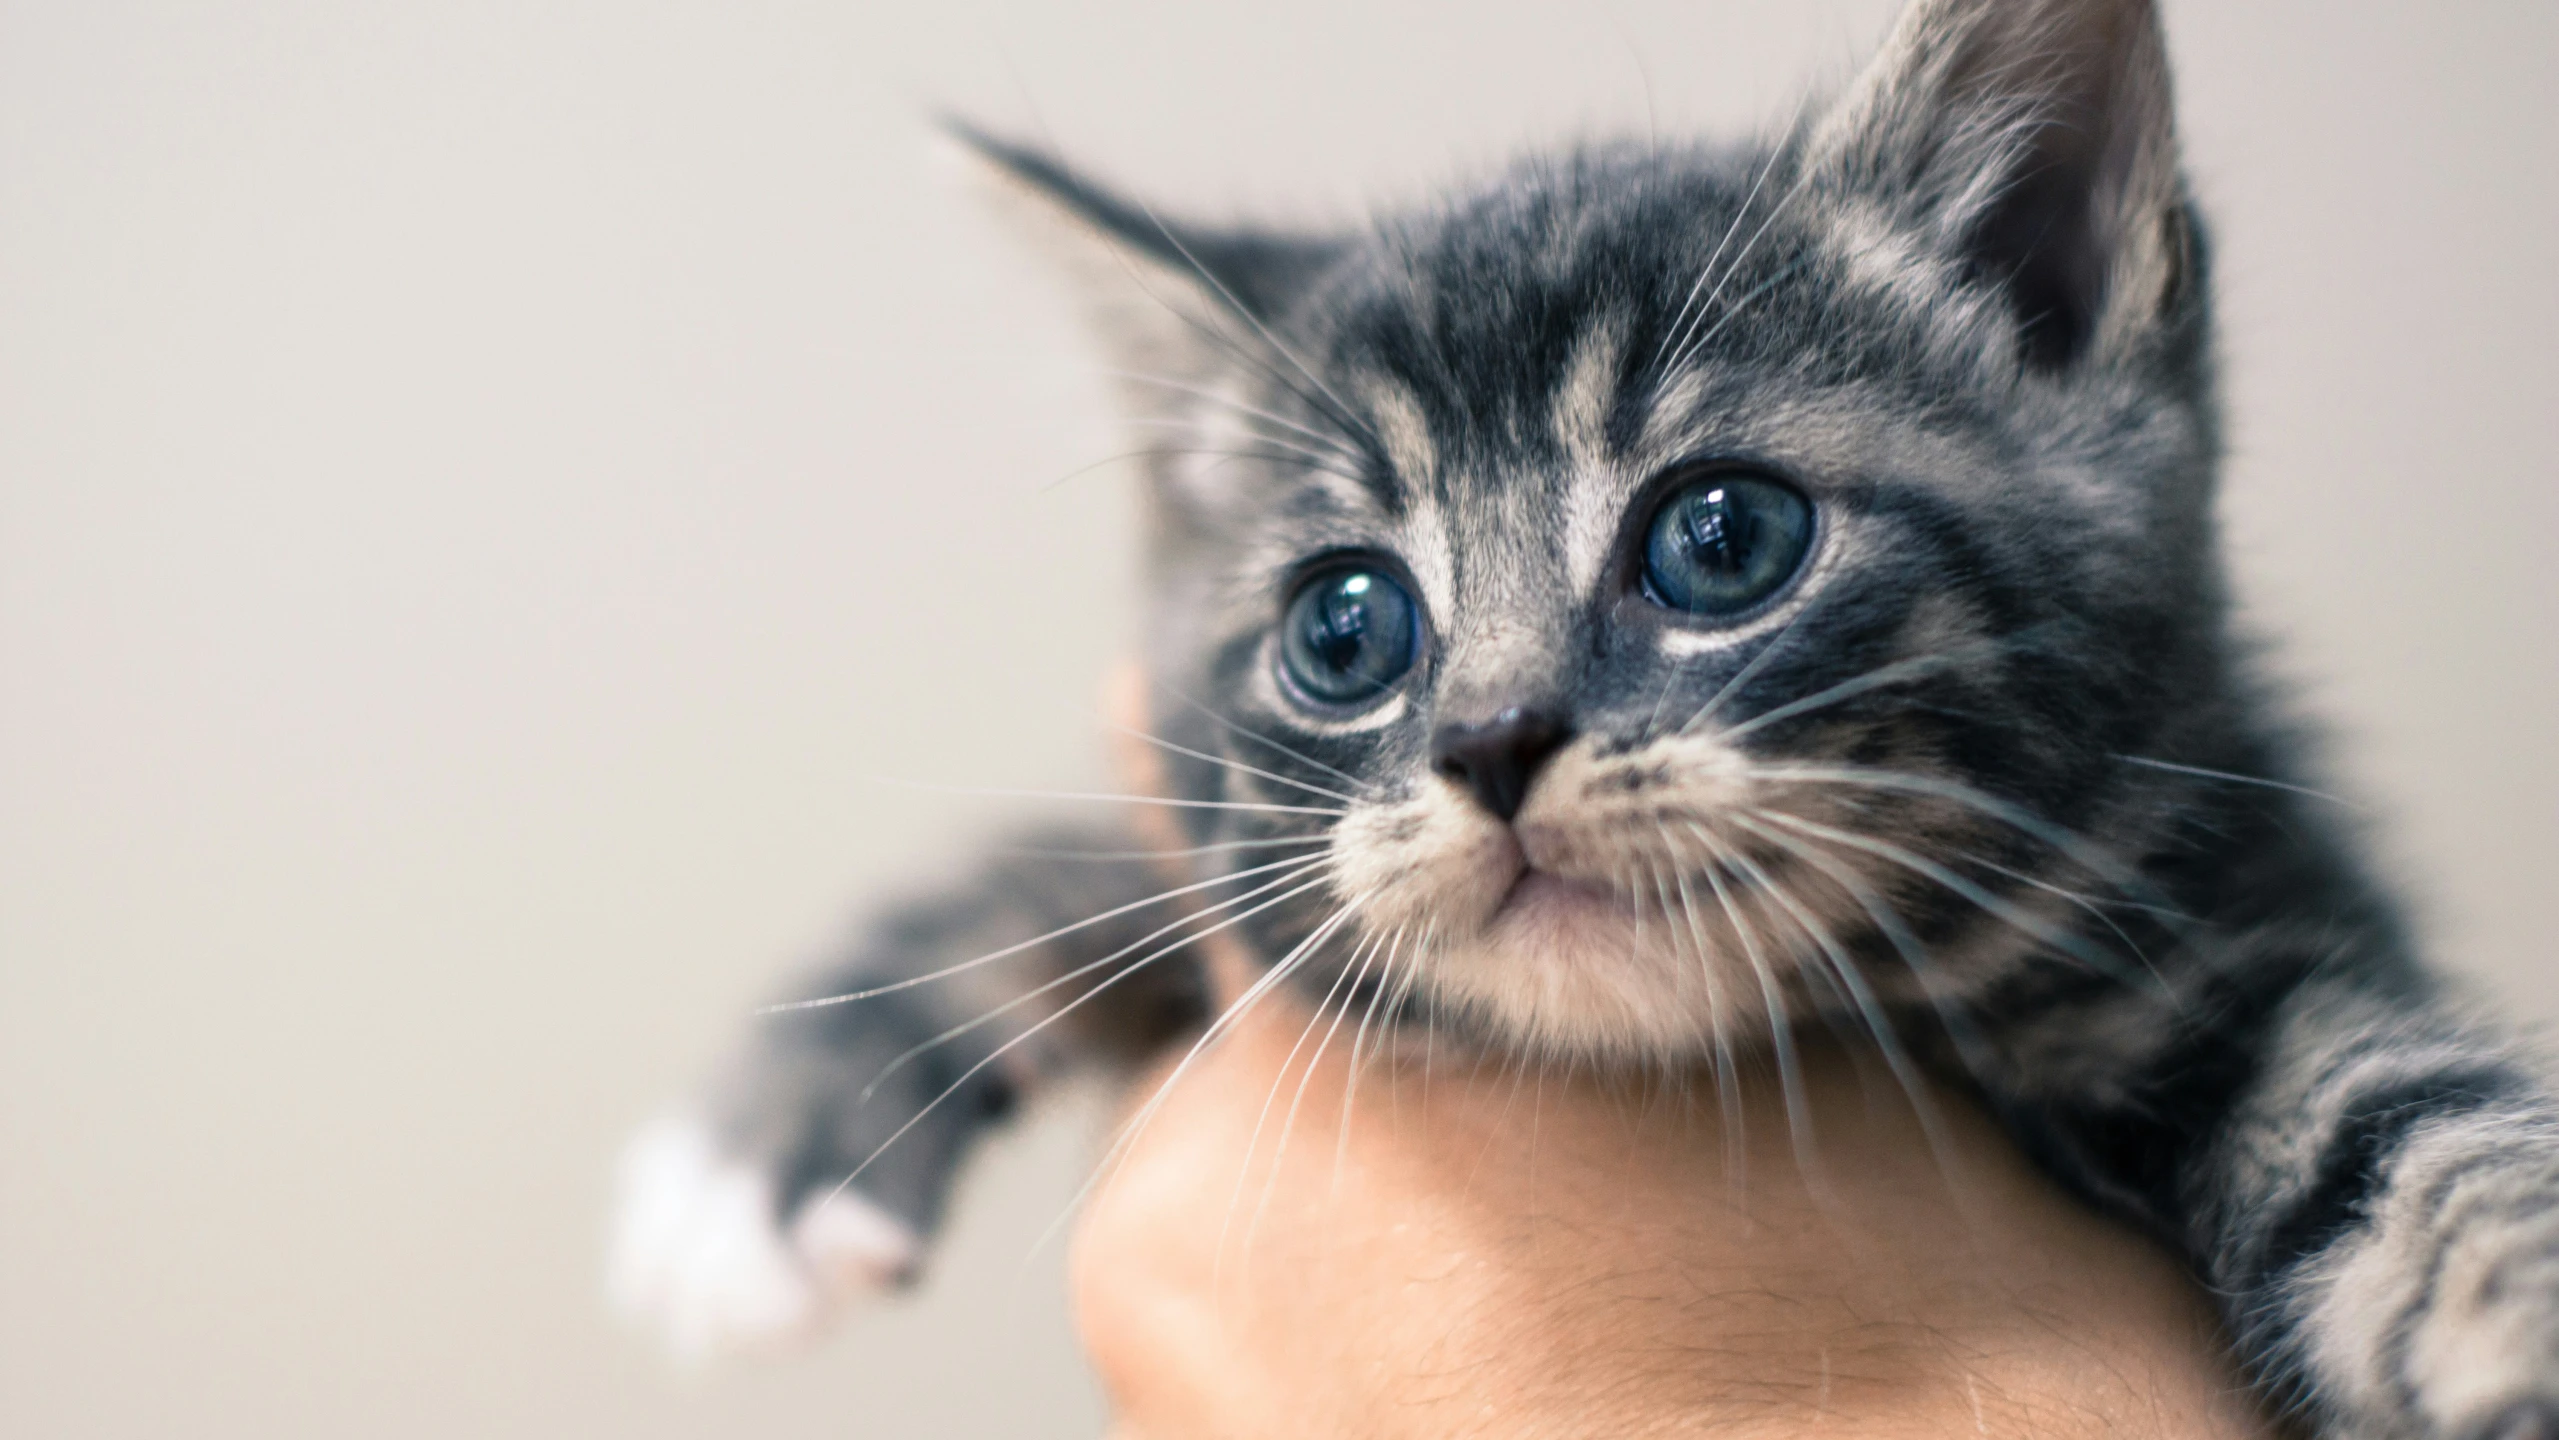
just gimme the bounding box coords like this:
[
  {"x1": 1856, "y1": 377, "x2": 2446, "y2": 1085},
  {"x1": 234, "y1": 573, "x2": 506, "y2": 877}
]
[{"x1": 1996, "y1": 944, "x2": 2559, "y2": 1440}]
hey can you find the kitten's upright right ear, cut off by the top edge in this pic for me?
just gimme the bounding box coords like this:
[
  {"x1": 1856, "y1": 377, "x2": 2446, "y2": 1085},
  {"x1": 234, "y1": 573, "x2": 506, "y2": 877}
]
[{"x1": 1812, "y1": 0, "x2": 2191, "y2": 368}]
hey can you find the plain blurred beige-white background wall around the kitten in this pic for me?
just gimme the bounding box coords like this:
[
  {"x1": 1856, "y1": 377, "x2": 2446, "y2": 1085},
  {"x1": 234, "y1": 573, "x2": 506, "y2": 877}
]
[{"x1": 0, "y1": 0, "x2": 2559, "y2": 1437}]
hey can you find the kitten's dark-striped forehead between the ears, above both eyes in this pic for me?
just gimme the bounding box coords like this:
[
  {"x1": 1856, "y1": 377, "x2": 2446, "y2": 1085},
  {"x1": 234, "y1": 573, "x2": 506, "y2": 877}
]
[{"x1": 1297, "y1": 148, "x2": 1986, "y2": 488}]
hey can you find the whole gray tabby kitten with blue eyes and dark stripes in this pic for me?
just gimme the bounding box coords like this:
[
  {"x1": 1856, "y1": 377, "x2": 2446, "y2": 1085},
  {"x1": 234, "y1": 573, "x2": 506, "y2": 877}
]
[{"x1": 619, "y1": 0, "x2": 2559, "y2": 1440}]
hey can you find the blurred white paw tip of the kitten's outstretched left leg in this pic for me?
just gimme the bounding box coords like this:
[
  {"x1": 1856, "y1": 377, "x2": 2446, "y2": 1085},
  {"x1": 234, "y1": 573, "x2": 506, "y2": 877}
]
[{"x1": 609, "y1": 1118, "x2": 919, "y2": 1361}]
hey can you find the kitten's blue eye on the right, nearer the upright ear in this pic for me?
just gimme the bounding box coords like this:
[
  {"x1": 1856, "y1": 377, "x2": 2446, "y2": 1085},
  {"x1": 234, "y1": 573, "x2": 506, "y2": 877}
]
[{"x1": 1643, "y1": 476, "x2": 1812, "y2": 614}]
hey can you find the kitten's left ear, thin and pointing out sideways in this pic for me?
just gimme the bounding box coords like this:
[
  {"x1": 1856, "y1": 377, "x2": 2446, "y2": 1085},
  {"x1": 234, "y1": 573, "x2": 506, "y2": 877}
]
[{"x1": 942, "y1": 120, "x2": 1338, "y2": 376}]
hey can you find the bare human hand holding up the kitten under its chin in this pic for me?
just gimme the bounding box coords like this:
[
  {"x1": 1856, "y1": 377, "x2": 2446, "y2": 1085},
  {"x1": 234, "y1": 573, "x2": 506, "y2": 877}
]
[{"x1": 1072, "y1": 957, "x2": 2272, "y2": 1440}]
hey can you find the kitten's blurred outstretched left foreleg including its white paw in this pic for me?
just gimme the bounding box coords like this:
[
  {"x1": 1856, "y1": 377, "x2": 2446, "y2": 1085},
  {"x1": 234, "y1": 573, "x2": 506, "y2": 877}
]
[{"x1": 612, "y1": 829, "x2": 1218, "y2": 1356}]
